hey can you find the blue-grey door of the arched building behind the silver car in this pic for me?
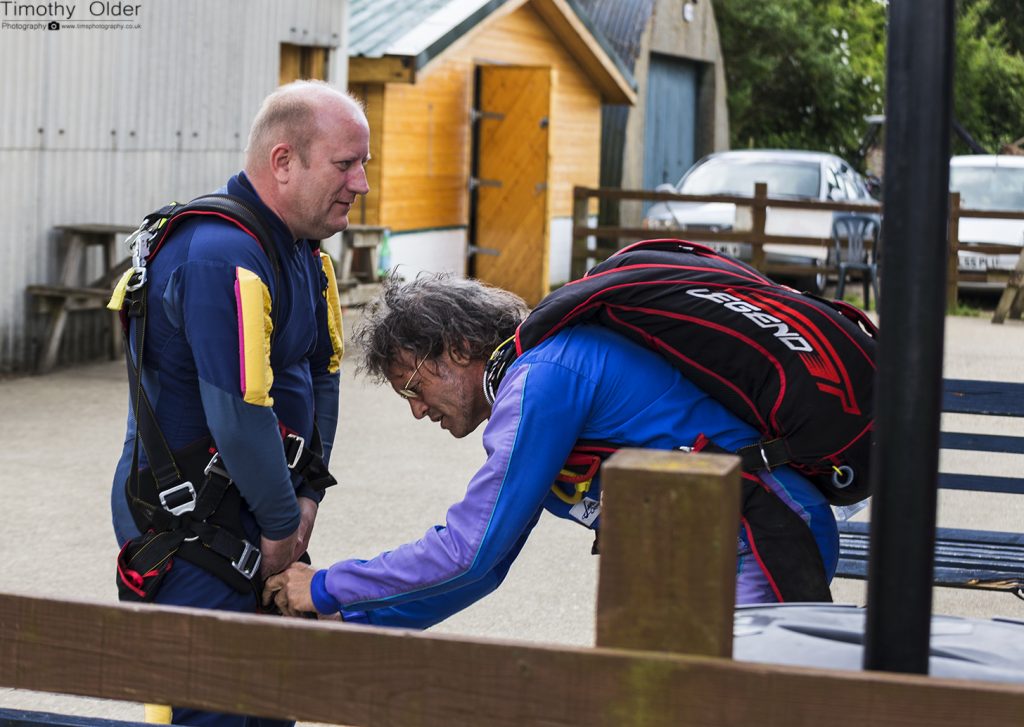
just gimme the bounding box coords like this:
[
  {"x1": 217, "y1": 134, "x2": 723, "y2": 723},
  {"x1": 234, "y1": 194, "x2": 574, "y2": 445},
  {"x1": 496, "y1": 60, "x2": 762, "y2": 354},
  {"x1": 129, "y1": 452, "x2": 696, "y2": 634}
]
[{"x1": 643, "y1": 53, "x2": 698, "y2": 196}]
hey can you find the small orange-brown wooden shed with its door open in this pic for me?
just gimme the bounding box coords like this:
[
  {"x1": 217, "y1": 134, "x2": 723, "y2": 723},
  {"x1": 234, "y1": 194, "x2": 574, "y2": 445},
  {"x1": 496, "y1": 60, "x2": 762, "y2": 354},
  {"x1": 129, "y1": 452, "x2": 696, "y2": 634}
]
[{"x1": 349, "y1": 0, "x2": 636, "y2": 304}]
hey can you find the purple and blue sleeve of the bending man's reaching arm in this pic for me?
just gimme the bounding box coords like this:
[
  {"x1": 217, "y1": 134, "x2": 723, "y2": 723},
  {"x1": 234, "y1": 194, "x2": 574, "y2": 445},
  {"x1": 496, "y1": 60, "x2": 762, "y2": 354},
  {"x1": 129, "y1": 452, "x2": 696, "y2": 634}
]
[{"x1": 314, "y1": 364, "x2": 594, "y2": 615}]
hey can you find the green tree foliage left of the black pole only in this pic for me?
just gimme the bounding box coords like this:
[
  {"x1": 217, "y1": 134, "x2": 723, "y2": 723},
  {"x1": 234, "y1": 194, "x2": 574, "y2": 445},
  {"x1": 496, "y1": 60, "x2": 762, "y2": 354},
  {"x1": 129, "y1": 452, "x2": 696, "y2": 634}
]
[{"x1": 715, "y1": 0, "x2": 885, "y2": 158}]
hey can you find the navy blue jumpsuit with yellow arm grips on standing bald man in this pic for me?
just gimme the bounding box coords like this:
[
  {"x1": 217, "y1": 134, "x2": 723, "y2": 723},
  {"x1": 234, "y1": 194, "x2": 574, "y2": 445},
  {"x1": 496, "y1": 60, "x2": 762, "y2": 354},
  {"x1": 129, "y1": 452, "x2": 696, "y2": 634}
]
[{"x1": 111, "y1": 173, "x2": 342, "y2": 727}]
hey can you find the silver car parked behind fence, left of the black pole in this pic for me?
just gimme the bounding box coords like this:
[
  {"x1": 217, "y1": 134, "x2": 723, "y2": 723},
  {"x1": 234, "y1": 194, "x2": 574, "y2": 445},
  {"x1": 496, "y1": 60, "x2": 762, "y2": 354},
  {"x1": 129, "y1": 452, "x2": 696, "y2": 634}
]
[{"x1": 644, "y1": 149, "x2": 873, "y2": 294}]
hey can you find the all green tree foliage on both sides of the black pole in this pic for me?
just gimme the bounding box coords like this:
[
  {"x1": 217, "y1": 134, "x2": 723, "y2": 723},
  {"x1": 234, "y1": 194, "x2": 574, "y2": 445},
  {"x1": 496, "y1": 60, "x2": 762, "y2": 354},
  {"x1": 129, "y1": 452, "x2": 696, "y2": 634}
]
[{"x1": 714, "y1": 0, "x2": 1024, "y2": 162}]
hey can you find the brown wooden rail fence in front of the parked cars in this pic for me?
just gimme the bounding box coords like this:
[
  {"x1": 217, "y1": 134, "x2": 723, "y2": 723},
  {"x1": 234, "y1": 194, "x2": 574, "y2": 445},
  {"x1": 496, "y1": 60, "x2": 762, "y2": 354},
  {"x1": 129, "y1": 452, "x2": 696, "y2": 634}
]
[{"x1": 571, "y1": 182, "x2": 1024, "y2": 310}]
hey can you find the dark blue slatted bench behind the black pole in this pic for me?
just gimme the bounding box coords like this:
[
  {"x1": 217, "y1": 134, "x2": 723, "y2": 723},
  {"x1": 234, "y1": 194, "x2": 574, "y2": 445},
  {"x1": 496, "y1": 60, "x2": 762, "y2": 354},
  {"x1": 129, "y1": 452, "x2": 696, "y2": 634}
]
[{"x1": 836, "y1": 379, "x2": 1024, "y2": 598}]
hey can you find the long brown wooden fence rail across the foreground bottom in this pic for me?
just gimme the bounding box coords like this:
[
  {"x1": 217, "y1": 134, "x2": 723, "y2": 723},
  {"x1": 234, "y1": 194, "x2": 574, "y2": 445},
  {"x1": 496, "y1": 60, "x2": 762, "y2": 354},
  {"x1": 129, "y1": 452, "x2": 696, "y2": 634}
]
[{"x1": 0, "y1": 595, "x2": 1024, "y2": 727}]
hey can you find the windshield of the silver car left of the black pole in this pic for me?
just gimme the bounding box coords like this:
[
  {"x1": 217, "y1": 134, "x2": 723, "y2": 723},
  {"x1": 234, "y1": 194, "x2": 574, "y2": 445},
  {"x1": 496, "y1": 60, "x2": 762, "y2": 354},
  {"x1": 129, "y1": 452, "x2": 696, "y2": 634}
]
[{"x1": 679, "y1": 159, "x2": 821, "y2": 199}]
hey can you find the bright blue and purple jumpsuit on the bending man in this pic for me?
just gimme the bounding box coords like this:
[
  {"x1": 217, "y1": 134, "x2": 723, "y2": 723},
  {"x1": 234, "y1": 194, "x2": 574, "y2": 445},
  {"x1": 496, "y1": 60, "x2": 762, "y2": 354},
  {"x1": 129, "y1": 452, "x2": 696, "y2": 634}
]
[{"x1": 311, "y1": 326, "x2": 839, "y2": 628}]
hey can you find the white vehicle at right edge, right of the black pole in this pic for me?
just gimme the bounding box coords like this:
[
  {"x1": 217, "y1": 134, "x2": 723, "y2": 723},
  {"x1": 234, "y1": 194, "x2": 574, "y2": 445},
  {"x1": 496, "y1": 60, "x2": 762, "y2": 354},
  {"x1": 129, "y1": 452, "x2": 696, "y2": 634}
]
[{"x1": 949, "y1": 155, "x2": 1024, "y2": 290}]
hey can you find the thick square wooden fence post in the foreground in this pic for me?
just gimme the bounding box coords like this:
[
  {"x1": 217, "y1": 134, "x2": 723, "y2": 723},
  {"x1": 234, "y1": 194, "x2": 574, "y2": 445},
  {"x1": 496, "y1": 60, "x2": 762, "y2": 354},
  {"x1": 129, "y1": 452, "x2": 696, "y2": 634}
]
[{"x1": 597, "y1": 450, "x2": 739, "y2": 658}]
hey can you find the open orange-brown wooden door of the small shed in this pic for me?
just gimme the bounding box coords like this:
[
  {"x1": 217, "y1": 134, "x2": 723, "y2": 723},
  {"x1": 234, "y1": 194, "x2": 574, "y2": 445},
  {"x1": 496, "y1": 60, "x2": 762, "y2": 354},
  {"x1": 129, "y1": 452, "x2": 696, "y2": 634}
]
[{"x1": 471, "y1": 66, "x2": 551, "y2": 305}]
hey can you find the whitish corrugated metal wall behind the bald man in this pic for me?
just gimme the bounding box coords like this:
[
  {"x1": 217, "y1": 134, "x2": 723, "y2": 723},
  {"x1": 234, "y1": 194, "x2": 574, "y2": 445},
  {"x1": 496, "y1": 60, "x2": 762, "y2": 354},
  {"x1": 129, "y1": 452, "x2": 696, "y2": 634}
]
[{"x1": 0, "y1": 0, "x2": 347, "y2": 372}]
